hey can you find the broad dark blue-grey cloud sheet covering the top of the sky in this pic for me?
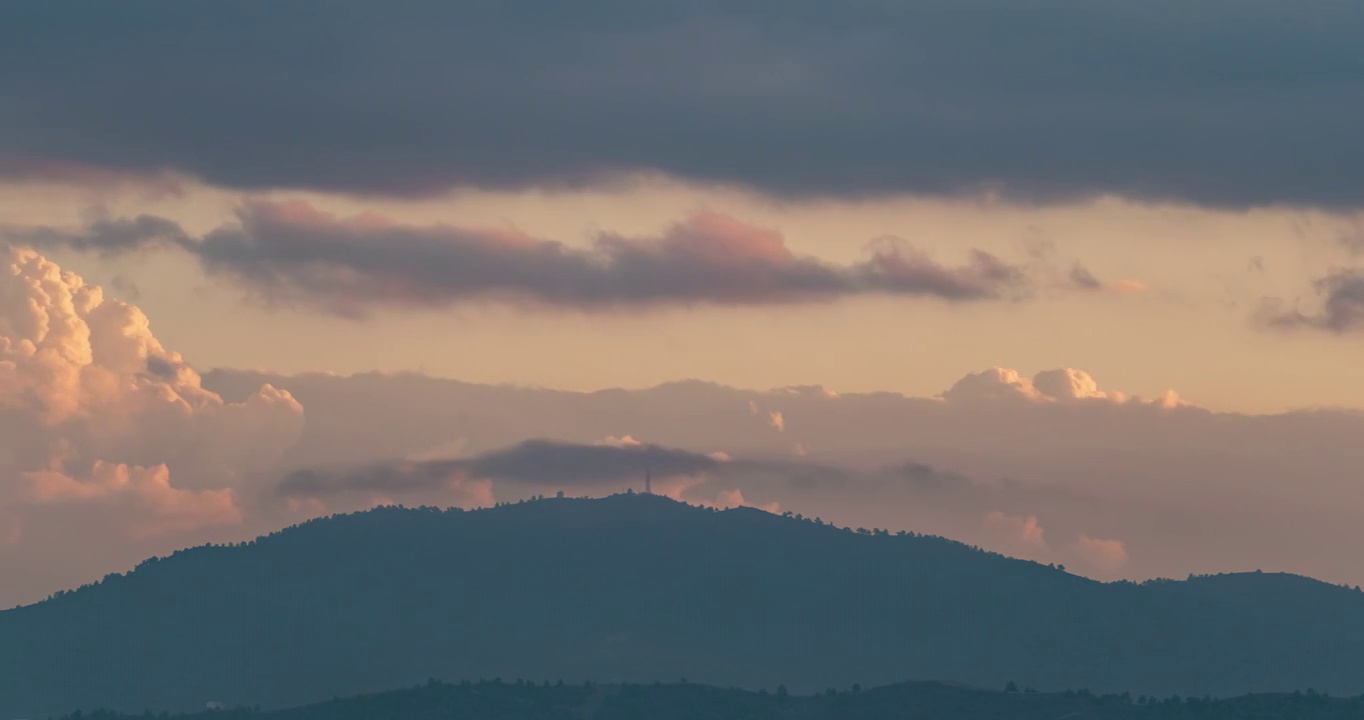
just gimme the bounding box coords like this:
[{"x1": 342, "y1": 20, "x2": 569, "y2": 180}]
[{"x1": 0, "y1": 0, "x2": 1364, "y2": 206}]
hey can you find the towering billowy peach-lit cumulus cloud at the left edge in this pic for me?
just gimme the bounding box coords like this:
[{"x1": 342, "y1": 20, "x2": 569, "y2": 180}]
[{"x1": 0, "y1": 248, "x2": 303, "y2": 600}]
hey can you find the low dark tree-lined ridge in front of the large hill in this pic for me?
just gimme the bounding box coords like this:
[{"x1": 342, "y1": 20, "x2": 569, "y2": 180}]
[{"x1": 64, "y1": 680, "x2": 1364, "y2": 720}]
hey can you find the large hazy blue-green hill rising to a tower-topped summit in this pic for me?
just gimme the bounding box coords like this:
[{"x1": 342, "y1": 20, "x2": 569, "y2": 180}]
[{"x1": 0, "y1": 494, "x2": 1364, "y2": 720}]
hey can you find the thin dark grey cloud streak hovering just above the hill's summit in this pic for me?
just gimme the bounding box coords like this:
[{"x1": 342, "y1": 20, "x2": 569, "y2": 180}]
[{"x1": 278, "y1": 440, "x2": 720, "y2": 496}]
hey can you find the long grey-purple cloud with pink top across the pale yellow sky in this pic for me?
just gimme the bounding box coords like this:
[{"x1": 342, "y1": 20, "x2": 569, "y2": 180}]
[{"x1": 5, "y1": 200, "x2": 1028, "y2": 315}]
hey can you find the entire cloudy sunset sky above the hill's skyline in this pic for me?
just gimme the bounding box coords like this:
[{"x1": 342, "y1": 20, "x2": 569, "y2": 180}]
[{"x1": 0, "y1": 0, "x2": 1364, "y2": 605}]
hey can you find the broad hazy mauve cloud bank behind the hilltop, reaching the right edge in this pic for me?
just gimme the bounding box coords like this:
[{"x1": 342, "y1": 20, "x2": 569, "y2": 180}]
[{"x1": 184, "y1": 368, "x2": 1364, "y2": 589}]
